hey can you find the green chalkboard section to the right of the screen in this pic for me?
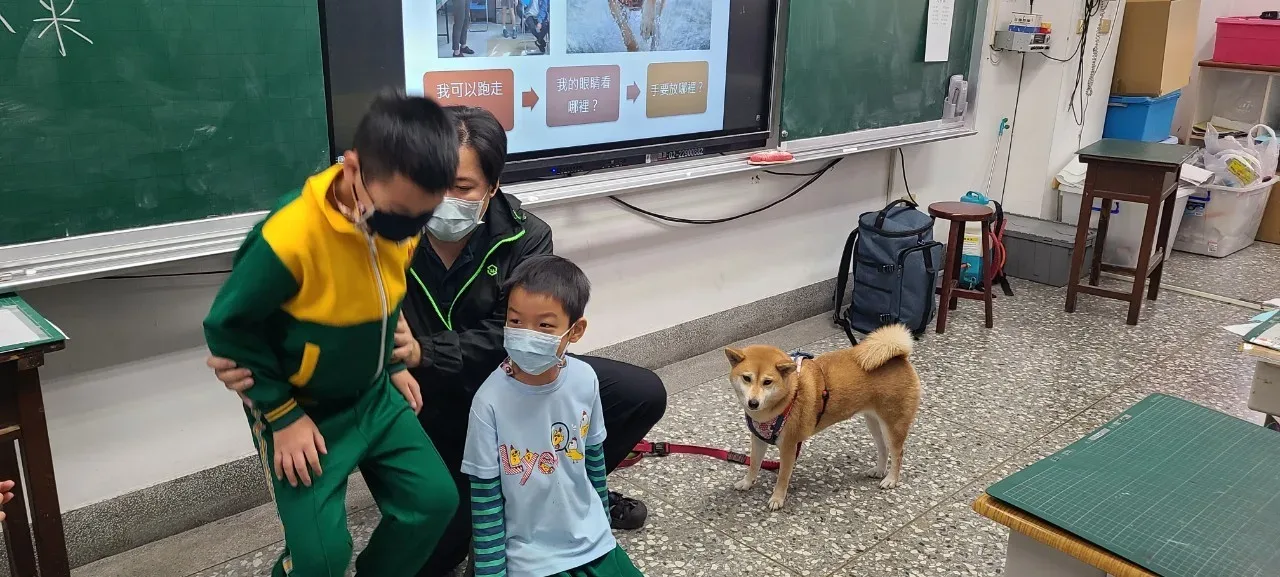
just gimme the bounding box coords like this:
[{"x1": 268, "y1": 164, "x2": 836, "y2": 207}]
[{"x1": 782, "y1": 0, "x2": 986, "y2": 139}]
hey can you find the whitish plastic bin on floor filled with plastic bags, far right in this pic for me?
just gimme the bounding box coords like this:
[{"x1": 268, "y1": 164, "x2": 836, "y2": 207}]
[{"x1": 1174, "y1": 178, "x2": 1276, "y2": 257}]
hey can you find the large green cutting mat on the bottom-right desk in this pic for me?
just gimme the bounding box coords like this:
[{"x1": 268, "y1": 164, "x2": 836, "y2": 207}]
[{"x1": 987, "y1": 394, "x2": 1280, "y2": 577}]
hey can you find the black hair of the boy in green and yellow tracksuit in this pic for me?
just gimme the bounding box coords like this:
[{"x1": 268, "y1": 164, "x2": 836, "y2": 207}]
[{"x1": 352, "y1": 91, "x2": 458, "y2": 194}]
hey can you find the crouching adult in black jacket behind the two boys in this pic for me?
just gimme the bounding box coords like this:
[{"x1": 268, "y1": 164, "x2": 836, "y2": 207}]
[{"x1": 209, "y1": 106, "x2": 667, "y2": 577}]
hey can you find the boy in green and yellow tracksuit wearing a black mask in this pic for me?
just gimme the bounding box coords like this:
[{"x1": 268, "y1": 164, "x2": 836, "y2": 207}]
[{"x1": 205, "y1": 95, "x2": 468, "y2": 577}]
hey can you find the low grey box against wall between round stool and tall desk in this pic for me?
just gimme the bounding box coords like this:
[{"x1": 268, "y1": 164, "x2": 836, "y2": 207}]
[{"x1": 1005, "y1": 212, "x2": 1097, "y2": 287}]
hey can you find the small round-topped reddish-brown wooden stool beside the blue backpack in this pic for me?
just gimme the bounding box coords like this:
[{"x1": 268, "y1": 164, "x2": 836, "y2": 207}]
[{"x1": 929, "y1": 202, "x2": 995, "y2": 334}]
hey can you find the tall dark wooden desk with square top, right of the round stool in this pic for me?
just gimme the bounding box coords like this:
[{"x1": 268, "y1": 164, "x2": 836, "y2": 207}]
[{"x1": 1066, "y1": 138, "x2": 1198, "y2": 325}]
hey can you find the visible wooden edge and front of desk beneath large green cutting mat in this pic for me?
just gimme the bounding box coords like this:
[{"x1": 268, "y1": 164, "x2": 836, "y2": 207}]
[{"x1": 973, "y1": 493, "x2": 1156, "y2": 577}]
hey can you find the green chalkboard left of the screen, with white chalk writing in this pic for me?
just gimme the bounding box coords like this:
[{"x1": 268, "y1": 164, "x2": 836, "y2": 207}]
[{"x1": 0, "y1": 0, "x2": 329, "y2": 246}]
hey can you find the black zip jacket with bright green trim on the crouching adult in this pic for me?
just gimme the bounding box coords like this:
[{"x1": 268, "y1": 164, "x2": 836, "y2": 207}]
[{"x1": 403, "y1": 192, "x2": 552, "y2": 404}]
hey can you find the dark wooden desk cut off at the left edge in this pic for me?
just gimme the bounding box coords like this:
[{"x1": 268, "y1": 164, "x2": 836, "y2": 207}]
[{"x1": 0, "y1": 296, "x2": 70, "y2": 577}]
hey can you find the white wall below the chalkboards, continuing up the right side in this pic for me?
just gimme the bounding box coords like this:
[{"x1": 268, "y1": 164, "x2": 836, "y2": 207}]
[{"x1": 17, "y1": 0, "x2": 1119, "y2": 509}]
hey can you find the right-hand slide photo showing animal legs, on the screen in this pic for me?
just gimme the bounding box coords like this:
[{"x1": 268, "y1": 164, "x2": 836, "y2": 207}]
[{"x1": 566, "y1": 0, "x2": 713, "y2": 54}]
